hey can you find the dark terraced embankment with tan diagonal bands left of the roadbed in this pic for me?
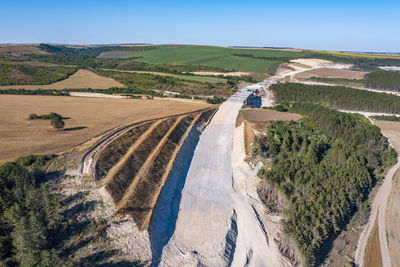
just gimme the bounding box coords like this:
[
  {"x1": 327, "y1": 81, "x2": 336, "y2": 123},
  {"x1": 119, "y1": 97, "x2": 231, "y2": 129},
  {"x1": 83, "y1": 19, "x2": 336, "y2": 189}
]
[{"x1": 95, "y1": 109, "x2": 216, "y2": 230}]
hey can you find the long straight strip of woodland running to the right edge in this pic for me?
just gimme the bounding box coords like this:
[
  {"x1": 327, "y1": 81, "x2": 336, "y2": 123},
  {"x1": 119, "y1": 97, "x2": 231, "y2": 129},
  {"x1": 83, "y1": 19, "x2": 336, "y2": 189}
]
[{"x1": 271, "y1": 83, "x2": 400, "y2": 113}]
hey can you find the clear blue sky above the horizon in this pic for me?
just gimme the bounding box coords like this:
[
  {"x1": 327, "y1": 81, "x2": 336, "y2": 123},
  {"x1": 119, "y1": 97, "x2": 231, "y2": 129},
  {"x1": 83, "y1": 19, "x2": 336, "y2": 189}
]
[{"x1": 0, "y1": 0, "x2": 400, "y2": 52}]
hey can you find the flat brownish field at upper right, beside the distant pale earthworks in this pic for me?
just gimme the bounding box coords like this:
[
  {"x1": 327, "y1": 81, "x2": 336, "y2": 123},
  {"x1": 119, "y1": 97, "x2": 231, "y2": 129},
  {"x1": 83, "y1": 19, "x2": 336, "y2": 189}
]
[{"x1": 296, "y1": 68, "x2": 368, "y2": 80}]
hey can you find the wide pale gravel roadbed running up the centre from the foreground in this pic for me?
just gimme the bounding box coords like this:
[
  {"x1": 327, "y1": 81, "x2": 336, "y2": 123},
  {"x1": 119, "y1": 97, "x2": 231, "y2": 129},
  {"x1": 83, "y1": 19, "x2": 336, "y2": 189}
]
[{"x1": 160, "y1": 99, "x2": 246, "y2": 266}]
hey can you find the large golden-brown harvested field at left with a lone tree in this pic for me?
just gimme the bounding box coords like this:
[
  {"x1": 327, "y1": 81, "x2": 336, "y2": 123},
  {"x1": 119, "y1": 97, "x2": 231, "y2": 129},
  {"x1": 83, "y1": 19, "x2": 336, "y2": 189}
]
[{"x1": 0, "y1": 95, "x2": 210, "y2": 162}]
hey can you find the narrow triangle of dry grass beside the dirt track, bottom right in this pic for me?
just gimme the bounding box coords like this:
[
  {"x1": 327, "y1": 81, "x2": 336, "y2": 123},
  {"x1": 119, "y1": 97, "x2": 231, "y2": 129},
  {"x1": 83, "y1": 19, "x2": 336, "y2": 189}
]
[{"x1": 364, "y1": 220, "x2": 382, "y2": 267}]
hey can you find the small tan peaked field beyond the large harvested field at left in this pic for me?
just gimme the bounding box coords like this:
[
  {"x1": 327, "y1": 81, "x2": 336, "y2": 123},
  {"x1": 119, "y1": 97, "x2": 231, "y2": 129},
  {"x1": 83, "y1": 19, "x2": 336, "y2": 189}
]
[{"x1": 0, "y1": 69, "x2": 125, "y2": 90}]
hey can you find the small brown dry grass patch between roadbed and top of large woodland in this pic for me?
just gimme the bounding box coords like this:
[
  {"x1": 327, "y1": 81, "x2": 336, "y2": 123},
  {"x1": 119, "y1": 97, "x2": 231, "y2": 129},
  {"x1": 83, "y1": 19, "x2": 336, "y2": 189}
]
[{"x1": 241, "y1": 109, "x2": 302, "y2": 122}]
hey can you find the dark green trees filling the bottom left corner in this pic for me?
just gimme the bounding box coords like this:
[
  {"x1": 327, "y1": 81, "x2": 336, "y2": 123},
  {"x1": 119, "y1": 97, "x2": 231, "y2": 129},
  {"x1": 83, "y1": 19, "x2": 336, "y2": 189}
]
[{"x1": 0, "y1": 156, "x2": 62, "y2": 266}]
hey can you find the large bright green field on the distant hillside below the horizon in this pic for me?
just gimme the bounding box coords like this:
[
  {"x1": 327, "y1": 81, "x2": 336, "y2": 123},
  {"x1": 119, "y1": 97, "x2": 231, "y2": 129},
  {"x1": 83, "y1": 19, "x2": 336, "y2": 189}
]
[{"x1": 122, "y1": 46, "x2": 307, "y2": 73}]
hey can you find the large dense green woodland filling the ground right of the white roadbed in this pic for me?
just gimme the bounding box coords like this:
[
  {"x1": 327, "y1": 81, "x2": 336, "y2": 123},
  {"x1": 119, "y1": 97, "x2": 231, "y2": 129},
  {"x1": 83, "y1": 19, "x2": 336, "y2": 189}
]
[{"x1": 255, "y1": 103, "x2": 396, "y2": 266}]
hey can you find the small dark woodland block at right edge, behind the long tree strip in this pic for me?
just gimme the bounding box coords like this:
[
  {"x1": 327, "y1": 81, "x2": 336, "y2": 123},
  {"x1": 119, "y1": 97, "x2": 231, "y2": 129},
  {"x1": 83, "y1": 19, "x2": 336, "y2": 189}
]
[{"x1": 365, "y1": 70, "x2": 400, "y2": 91}]
